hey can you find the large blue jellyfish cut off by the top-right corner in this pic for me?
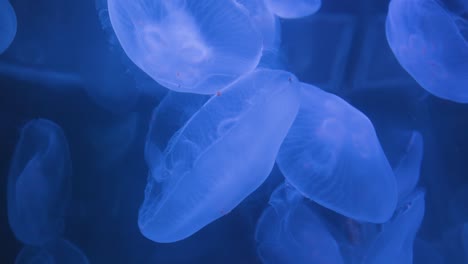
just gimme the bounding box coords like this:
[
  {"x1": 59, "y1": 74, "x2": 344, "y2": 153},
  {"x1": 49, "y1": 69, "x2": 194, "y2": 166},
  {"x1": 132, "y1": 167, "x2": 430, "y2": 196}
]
[{"x1": 386, "y1": 0, "x2": 468, "y2": 103}]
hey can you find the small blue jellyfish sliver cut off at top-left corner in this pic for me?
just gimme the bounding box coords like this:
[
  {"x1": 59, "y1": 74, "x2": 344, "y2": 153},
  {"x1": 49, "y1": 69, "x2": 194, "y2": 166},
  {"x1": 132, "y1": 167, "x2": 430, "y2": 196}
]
[{"x1": 0, "y1": 0, "x2": 17, "y2": 54}]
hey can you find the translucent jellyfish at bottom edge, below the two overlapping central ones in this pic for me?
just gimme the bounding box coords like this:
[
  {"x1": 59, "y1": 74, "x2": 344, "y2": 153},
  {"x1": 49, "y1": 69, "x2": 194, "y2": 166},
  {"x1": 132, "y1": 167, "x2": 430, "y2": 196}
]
[{"x1": 255, "y1": 184, "x2": 344, "y2": 264}]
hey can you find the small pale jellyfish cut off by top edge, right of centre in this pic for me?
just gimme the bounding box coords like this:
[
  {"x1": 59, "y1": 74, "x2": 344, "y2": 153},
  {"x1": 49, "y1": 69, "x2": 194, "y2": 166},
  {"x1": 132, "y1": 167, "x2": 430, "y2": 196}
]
[{"x1": 265, "y1": 0, "x2": 322, "y2": 18}]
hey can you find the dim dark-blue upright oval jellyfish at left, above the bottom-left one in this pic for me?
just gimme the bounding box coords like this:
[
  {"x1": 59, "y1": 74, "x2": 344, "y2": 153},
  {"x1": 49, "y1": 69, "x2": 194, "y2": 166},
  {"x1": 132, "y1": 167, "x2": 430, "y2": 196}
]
[{"x1": 7, "y1": 119, "x2": 71, "y2": 245}]
